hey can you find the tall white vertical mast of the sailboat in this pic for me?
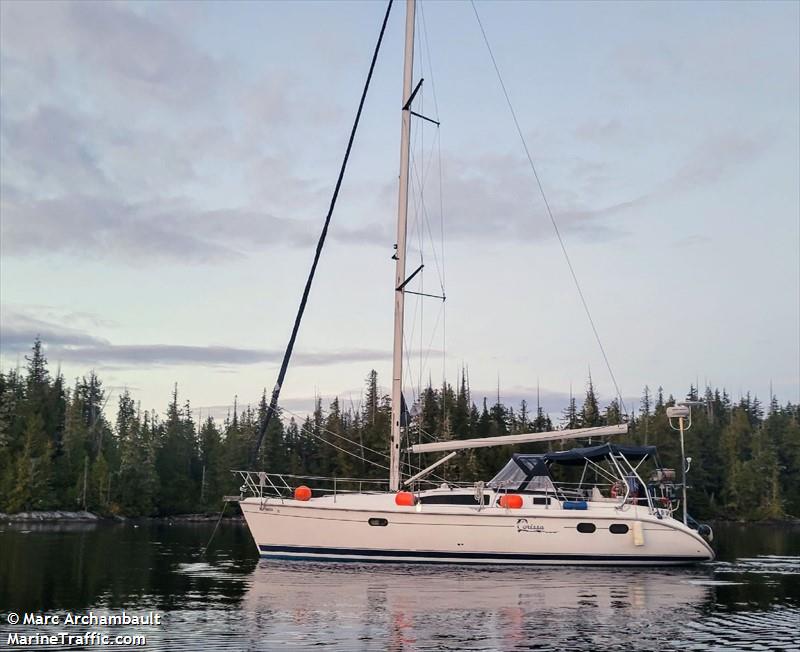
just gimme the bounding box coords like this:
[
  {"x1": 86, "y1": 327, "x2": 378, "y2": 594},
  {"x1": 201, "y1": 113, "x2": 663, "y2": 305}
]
[{"x1": 389, "y1": 0, "x2": 416, "y2": 491}]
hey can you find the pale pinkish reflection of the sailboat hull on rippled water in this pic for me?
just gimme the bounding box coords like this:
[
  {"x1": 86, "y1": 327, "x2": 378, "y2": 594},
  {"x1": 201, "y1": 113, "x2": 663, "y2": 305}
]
[{"x1": 242, "y1": 561, "x2": 713, "y2": 649}]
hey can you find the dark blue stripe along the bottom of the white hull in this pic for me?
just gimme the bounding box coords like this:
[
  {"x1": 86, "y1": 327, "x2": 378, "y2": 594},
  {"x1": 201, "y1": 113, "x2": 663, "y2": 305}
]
[{"x1": 259, "y1": 545, "x2": 706, "y2": 564}]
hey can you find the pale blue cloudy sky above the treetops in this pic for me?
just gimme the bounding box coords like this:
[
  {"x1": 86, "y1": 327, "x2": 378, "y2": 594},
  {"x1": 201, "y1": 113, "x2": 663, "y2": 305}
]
[{"x1": 0, "y1": 1, "x2": 800, "y2": 416}]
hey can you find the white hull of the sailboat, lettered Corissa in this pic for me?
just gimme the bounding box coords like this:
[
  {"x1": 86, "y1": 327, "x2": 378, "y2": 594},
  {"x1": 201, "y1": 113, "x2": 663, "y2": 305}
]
[{"x1": 241, "y1": 494, "x2": 714, "y2": 566}]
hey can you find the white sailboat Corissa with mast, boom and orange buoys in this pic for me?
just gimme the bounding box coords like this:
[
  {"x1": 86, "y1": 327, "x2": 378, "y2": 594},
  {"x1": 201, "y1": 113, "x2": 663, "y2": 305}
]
[{"x1": 236, "y1": 0, "x2": 714, "y2": 565}]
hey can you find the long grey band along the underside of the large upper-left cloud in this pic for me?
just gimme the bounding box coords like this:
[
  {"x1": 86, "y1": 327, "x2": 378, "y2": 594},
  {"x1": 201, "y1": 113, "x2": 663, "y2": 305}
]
[{"x1": 0, "y1": 186, "x2": 386, "y2": 265}]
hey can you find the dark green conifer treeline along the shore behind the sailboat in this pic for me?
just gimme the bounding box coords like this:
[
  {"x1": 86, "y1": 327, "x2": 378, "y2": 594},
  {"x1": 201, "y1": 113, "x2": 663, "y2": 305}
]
[{"x1": 0, "y1": 340, "x2": 800, "y2": 519}]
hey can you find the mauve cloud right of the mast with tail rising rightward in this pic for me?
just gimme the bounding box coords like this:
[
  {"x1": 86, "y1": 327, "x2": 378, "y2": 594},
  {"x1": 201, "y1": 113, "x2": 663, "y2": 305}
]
[{"x1": 428, "y1": 125, "x2": 776, "y2": 247}]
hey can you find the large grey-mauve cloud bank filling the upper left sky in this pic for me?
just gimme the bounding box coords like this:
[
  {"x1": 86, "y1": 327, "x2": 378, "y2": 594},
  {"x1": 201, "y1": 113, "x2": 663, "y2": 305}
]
[{"x1": 0, "y1": 2, "x2": 372, "y2": 265}]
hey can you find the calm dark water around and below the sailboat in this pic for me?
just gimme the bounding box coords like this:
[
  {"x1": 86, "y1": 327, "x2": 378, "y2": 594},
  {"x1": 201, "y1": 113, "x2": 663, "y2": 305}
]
[{"x1": 0, "y1": 523, "x2": 800, "y2": 651}]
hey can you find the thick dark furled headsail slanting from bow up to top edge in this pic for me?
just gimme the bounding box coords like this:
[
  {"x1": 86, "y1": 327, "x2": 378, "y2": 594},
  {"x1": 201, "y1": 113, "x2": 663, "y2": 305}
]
[{"x1": 250, "y1": 0, "x2": 393, "y2": 468}]
